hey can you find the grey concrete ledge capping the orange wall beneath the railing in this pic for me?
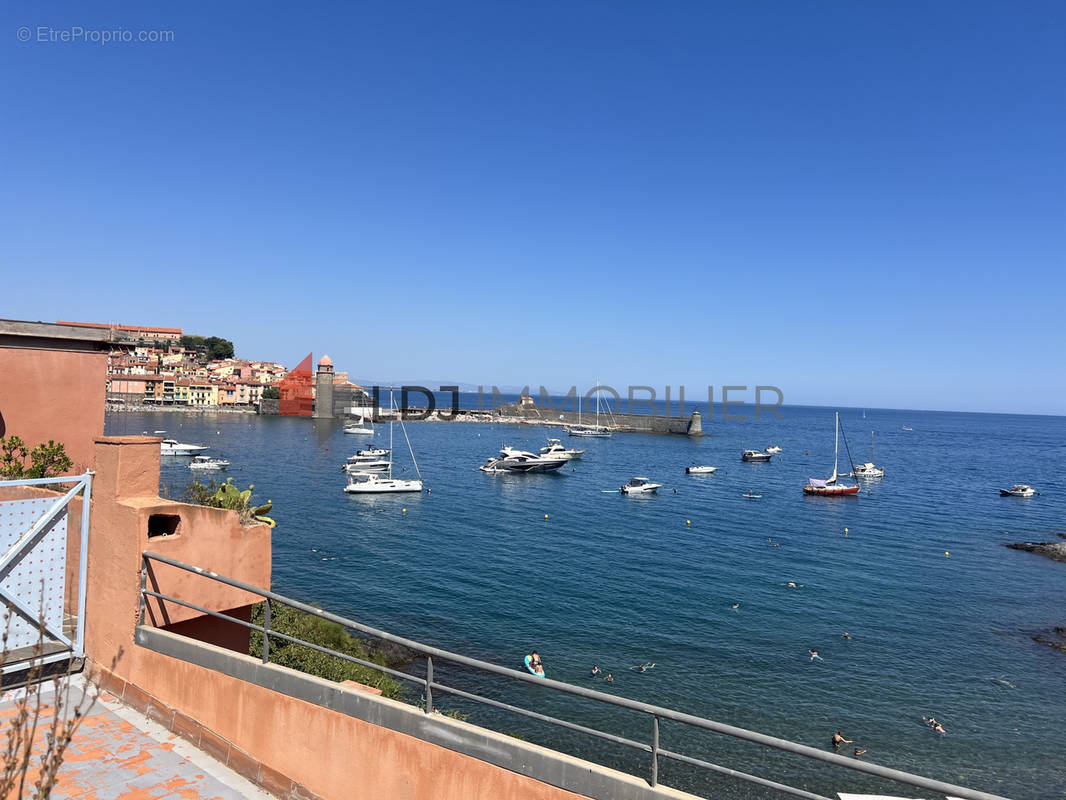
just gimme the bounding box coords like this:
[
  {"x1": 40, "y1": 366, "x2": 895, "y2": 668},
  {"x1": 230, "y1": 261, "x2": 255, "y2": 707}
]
[{"x1": 136, "y1": 625, "x2": 696, "y2": 800}]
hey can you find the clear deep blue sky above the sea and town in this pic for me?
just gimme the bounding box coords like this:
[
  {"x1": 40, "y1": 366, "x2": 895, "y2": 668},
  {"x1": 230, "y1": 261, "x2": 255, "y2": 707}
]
[{"x1": 0, "y1": 0, "x2": 1066, "y2": 414}]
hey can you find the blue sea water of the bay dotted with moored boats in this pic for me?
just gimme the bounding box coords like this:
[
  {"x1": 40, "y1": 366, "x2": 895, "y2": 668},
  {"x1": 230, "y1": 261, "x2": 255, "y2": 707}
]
[{"x1": 108, "y1": 407, "x2": 1066, "y2": 798}]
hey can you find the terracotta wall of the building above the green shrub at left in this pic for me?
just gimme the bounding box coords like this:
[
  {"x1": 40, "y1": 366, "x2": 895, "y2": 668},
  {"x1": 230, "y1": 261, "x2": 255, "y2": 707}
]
[{"x1": 0, "y1": 348, "x2": 108, "y2": 473}]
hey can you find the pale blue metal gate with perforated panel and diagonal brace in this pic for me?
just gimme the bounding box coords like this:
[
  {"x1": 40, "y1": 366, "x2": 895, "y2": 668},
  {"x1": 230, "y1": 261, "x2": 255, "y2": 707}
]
[{"x1": 0, "y1": 473, "x2": 93, "y2": 674}]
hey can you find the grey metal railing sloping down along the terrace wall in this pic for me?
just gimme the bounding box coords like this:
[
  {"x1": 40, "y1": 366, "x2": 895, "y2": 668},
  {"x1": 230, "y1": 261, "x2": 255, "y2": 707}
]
[{"x1": 141, "y1": 551, "x2": 1006, "y2": 800}]
